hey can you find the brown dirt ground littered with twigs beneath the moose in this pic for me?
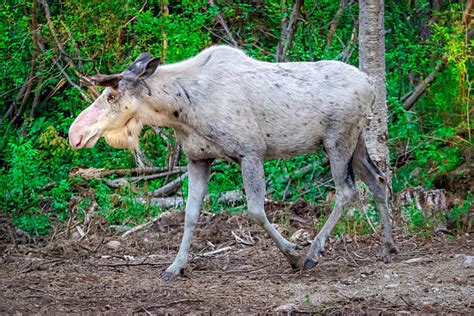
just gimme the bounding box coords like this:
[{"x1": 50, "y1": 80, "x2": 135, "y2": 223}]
[{"x1": 0, "y1": 207, "x2": 474, "y2": 314}]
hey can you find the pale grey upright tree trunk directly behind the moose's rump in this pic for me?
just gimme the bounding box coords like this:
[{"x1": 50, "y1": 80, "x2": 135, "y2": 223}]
[{"x1": 359, "y1": 0, "x2": 391, "y2": 175}]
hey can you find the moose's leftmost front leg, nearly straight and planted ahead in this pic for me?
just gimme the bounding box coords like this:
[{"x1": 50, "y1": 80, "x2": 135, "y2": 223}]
[{"x1": 161, "y1": 160, "x2": 212, "y2": 281}]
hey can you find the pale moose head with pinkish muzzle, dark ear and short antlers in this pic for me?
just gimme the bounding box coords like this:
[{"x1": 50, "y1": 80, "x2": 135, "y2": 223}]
[{"x1": 69, "y1": 53, "x2": 160, "y2": 149}]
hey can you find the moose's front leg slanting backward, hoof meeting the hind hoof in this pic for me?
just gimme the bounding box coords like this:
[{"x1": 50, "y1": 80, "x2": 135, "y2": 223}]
[{"x1": 241, "y1": 157, "x2": 301, "y2": 268}]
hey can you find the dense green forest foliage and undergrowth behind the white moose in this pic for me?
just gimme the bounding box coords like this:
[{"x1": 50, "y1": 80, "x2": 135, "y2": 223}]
[{"x1": 0, "y1": 0, "x2": 473, "y2": 235}]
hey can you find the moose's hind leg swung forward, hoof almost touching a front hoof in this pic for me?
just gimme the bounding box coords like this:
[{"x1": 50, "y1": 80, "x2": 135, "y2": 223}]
[{"x1": 303, "y1": 146, "x2": 358, "y2": 270}]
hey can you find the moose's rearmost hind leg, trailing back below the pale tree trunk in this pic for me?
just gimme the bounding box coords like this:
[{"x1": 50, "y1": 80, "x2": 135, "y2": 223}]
[{"x1": 352, "y1": 136, "x2": 398, "y2": 263}]
